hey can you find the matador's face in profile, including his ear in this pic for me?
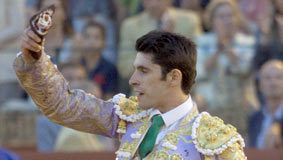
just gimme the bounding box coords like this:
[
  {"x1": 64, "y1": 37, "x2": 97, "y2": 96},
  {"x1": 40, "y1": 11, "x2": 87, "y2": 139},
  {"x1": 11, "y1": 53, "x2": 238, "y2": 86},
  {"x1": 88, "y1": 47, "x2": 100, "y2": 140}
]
[{"x1": 129, "y1": 52, "x2": 170, "y2": 109}]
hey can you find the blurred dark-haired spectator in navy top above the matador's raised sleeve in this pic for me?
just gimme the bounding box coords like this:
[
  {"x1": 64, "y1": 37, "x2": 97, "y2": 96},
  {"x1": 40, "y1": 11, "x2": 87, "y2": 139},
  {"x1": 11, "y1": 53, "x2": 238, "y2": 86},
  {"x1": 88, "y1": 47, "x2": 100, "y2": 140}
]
[{"x1": 73, "y1": 21, "x2": 118, "y2": 99}]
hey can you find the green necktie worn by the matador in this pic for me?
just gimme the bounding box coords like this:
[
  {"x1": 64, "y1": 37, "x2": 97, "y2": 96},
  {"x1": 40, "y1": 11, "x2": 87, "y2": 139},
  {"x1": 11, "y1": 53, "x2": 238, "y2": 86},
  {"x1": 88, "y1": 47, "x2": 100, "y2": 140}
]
[{"x1": 139, "y1": 115, "x2": 164, "y2": 159}]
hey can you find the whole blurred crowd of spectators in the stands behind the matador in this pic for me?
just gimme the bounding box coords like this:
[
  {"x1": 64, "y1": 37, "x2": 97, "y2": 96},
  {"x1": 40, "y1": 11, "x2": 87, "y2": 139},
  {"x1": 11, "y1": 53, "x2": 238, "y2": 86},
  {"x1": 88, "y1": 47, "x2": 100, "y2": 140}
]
[{"x1": 0, "y1": 0, "x2": 283, "y2": 155}]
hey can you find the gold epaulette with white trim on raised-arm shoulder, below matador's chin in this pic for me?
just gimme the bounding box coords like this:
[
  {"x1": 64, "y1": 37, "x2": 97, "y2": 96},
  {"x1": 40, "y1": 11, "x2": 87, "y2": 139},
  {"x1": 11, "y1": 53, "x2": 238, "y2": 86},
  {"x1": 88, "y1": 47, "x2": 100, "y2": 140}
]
[{"x1": 112, "y1": 93, "x2": 151, "y2": 133}]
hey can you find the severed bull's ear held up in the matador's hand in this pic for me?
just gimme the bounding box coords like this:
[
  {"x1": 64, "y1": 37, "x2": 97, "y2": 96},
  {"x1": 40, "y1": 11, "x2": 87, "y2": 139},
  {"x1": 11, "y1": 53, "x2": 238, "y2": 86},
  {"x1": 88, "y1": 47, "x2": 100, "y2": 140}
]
[{"x1": 30, "y1": 5, "x2": 55, "y2": 59}]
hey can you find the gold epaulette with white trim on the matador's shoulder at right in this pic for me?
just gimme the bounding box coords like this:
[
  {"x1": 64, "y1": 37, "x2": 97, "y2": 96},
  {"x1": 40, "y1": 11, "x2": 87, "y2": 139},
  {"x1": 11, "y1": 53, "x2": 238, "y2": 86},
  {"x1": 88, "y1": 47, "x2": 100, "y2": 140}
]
[{"x1": 192, "y1": 112, "x2": 245, "y2": 156}]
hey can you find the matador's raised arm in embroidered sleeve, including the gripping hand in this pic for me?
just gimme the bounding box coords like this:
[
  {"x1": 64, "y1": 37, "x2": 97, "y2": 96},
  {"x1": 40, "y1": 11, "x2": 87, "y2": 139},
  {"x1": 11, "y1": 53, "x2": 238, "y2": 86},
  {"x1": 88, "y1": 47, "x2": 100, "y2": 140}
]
[{"x1": 14, "y1": 29, "x2": 119, "y2": 137}]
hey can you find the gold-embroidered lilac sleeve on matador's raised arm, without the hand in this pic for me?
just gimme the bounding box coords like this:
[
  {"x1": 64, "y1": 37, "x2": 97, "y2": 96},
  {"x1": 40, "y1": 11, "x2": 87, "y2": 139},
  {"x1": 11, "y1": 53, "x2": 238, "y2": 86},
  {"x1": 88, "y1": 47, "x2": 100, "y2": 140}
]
[{"x1": 15, "y1": 53, "x2": 113, "y2": 134}]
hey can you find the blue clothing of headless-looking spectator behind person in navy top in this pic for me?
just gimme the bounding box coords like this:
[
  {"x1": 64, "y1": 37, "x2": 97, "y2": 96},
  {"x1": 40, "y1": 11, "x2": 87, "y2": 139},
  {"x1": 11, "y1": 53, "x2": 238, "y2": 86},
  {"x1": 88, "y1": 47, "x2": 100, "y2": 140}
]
[{"x1": 67, "y1": 0, "x2": 117, "y2": 64}]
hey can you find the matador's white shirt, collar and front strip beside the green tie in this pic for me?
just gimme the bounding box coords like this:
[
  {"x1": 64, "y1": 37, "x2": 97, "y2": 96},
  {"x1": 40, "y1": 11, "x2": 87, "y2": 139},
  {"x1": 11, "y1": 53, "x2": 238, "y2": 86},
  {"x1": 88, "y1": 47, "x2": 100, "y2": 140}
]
[{"x1": 149, "y1": 96, "x2": 194, "y2": 144}]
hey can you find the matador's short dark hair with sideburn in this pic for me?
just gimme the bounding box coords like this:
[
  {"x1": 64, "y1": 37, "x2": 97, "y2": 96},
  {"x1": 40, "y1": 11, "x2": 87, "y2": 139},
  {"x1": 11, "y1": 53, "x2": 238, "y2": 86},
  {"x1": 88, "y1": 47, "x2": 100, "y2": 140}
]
[{"x1": 136, "y1": 31, "x2": 197, "y2": 94}]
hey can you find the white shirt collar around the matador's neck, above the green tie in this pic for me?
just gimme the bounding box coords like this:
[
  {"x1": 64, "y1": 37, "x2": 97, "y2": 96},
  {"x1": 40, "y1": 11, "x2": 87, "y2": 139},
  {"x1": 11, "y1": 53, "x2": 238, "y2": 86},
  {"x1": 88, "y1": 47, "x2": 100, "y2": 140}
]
[{"x1": 150, "y1": 96, "x2": 193, "y2": 127}]
